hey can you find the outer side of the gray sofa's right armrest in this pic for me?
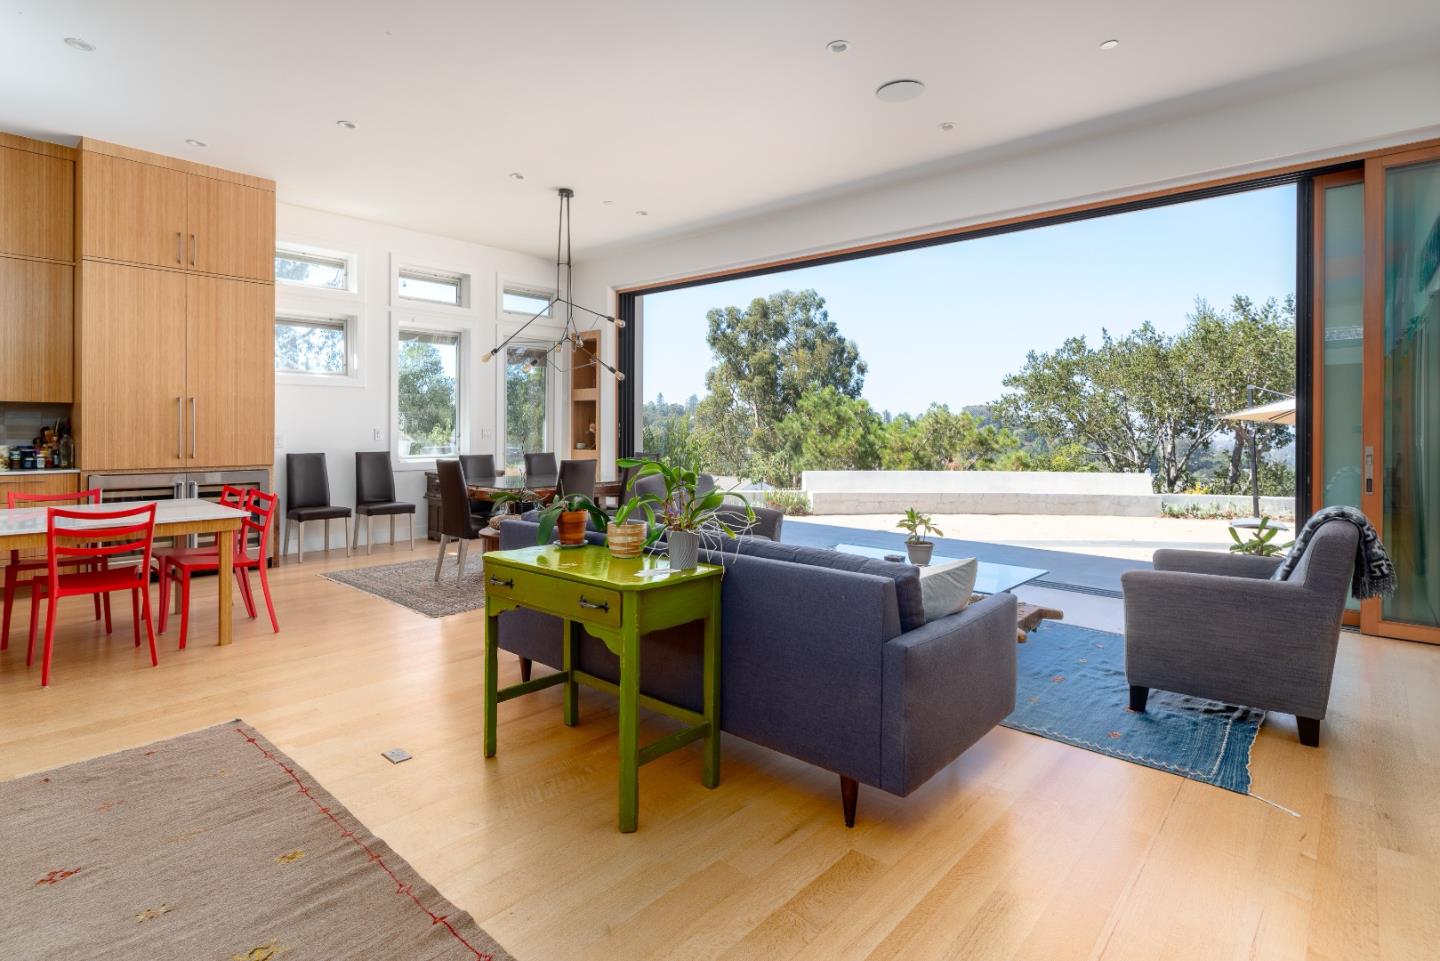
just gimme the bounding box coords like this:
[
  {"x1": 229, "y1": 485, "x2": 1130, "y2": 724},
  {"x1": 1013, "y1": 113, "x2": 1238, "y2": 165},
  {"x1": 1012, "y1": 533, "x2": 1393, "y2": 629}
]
[{"x1": 881, "y1": 594, "x2": 1018, "y2": 797}]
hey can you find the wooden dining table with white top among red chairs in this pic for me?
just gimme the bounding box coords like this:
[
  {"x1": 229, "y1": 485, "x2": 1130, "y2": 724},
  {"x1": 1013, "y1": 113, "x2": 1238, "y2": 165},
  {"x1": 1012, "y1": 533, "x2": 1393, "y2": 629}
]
[{"x1": 0, "y1": 497, "x2": 248, "y2": 644}]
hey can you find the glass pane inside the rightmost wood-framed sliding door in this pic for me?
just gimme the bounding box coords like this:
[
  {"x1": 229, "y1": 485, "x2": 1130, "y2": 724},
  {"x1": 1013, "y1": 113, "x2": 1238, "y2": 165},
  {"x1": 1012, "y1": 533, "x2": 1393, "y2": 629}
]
[{"x1": 1382, "y1": 163, "x2": 1440, "y2": 627}]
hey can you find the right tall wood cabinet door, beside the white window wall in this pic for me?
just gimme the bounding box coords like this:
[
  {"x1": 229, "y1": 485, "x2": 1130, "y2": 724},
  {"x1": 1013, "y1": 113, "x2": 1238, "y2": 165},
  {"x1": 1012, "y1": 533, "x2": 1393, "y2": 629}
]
[{"x1": 186, "y1": 277, "x2": 275, "y2": 467}]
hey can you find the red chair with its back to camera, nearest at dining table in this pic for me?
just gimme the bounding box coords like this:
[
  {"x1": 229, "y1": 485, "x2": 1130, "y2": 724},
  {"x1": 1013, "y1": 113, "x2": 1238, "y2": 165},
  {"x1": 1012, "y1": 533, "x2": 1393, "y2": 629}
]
[{"x1": 24, "y1": 504, "x2": 160, "y2": 687}]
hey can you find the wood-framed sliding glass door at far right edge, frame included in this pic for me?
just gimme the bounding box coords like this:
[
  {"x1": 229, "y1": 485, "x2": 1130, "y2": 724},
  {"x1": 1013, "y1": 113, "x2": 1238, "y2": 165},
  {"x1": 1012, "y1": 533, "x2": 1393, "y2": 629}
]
[{"x1": 1361, "y1": 148, "x2": 1440, "y2": 643}]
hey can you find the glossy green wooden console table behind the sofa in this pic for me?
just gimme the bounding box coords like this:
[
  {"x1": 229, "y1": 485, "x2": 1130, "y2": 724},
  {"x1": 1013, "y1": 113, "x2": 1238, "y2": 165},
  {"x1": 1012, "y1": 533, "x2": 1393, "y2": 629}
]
[{"x1": 485, "y1": 545, "x2": 721, "y2": 831}]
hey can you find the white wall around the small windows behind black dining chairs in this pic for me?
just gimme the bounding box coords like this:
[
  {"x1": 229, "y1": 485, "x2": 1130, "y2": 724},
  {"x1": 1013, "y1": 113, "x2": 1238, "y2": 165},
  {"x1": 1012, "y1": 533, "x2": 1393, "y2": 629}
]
[{"x1": 274, "y1": 203, "x2": 555, "y2": 549}]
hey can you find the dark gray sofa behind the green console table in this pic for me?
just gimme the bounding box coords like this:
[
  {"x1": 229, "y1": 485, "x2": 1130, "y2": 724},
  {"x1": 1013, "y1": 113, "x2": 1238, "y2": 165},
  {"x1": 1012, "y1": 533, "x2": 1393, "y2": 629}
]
[{"x1": 500, "y1": 520, "x2": 1015, "y2": 826}]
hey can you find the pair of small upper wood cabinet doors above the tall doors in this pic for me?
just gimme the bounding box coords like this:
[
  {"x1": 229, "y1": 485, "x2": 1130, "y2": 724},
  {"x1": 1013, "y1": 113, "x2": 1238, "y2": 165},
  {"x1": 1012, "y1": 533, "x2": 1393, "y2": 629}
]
[{"x1": 79, "y1": 138, "x2": 275, "y2": 281}]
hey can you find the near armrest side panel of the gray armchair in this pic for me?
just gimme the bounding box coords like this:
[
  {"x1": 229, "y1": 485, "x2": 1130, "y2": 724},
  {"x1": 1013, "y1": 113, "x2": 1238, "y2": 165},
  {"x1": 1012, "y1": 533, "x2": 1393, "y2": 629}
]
[{"x1": 1120, "y1": 571, "x2": 1341, "y2": 718}]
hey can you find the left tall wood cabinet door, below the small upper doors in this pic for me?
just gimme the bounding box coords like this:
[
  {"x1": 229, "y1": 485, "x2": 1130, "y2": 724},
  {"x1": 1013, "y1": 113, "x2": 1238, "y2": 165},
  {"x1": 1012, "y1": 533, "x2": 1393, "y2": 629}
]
[{"x1": 76, "y1": 262, "x2": 186, "y2": 470}]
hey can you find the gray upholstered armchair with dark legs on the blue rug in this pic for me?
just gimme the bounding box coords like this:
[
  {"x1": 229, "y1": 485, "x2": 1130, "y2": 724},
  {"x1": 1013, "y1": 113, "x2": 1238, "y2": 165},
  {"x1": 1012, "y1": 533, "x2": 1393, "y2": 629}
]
[{"x1": 1120, "y1": 522, "x2": 1359, "y2": 748}]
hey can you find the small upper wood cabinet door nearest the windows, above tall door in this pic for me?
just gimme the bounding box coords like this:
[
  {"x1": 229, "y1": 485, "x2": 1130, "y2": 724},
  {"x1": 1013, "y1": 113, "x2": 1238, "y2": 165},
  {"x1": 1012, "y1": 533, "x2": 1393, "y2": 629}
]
[{"x1": 186, "y1": 174, "x2": 275, "y2": 281}]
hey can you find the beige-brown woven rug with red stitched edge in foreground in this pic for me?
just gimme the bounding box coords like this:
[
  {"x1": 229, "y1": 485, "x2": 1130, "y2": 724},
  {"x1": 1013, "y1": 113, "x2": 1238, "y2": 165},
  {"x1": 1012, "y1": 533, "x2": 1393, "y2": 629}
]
[{"x1": 0, "y1": 720, "x2": 513, "y2": 961}]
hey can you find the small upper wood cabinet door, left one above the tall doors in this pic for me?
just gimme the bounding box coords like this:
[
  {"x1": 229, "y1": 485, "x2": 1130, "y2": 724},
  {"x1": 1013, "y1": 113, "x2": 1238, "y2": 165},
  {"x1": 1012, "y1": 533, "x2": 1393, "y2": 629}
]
[{"x1": 81, "y1": 151, "x2": 189, "y2": 267}]
